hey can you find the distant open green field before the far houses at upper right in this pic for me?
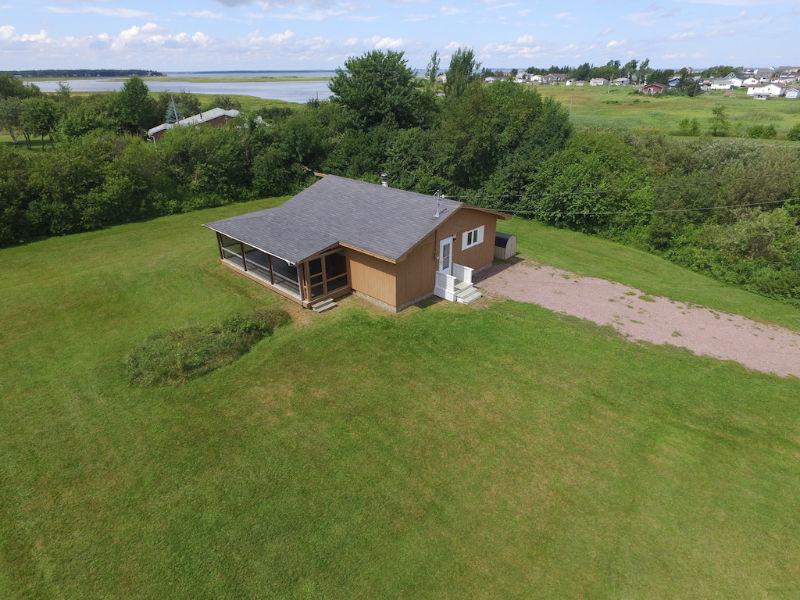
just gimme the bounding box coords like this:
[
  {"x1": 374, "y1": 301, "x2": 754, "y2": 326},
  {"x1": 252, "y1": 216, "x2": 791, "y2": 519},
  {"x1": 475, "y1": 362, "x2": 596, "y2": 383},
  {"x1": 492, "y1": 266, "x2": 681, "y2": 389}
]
[{"x1": 535, "y1": 85, "x2": 800, "y2": 138}]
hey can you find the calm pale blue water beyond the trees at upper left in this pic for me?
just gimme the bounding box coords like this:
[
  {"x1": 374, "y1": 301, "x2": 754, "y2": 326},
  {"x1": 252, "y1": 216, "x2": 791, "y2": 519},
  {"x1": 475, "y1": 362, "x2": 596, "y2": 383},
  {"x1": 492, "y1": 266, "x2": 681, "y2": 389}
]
[{"x1": 35, "y1": 77, "x2": 331, "y2": 102}]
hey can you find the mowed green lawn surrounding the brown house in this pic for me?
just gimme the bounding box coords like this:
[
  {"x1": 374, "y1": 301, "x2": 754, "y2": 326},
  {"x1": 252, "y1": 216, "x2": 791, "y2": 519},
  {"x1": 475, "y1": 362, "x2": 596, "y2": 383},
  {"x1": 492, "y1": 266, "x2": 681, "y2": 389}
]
[{"x1": 0, "y1": 200, "x2": 800, "y2": 599}]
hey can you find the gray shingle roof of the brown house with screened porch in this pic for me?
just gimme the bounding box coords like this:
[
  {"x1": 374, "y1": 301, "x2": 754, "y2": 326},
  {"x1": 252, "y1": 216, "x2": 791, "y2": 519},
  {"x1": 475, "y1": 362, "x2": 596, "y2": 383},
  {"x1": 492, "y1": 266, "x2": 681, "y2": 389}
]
[{"x1": 206, "y1": 175, "x2": 461, "y2": 263}]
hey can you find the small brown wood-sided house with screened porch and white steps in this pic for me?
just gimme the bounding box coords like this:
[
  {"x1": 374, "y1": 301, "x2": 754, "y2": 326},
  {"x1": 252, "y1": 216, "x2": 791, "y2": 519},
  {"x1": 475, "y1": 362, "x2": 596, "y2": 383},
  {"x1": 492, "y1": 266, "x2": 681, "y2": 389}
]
[{"x1": 205, "y1": 175, "x2": 506, "y2": 312}]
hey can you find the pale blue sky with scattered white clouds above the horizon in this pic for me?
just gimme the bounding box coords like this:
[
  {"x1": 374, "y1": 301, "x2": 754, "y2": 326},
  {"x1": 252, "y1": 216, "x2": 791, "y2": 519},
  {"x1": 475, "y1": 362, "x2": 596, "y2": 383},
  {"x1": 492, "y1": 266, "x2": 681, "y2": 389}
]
[{"x1": 0, "y1": 0, "x2": 800, "y2": 71}]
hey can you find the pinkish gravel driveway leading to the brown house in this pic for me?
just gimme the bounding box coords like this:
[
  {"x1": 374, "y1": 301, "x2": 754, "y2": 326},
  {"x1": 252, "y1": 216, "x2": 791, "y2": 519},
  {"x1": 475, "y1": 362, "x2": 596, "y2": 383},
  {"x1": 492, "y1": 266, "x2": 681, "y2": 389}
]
[{"x1": 476, "y1": 262, "x2": 800, "y2": 377}]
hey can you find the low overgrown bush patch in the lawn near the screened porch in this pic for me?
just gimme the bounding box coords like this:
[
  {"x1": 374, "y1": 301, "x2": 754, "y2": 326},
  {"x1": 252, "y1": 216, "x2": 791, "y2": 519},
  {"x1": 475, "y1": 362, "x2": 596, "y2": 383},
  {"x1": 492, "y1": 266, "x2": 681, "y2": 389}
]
[{"x1": 127, "y1": 309, "x2": 291, "y2": 386}]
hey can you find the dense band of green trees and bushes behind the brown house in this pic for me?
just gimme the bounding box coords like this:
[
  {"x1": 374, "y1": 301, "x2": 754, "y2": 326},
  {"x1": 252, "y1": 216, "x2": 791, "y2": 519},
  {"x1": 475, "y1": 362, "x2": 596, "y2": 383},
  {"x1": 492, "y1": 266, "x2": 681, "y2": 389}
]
[{"x1": 0, "y1": 49, "x2": 800, "y2": 302}]
